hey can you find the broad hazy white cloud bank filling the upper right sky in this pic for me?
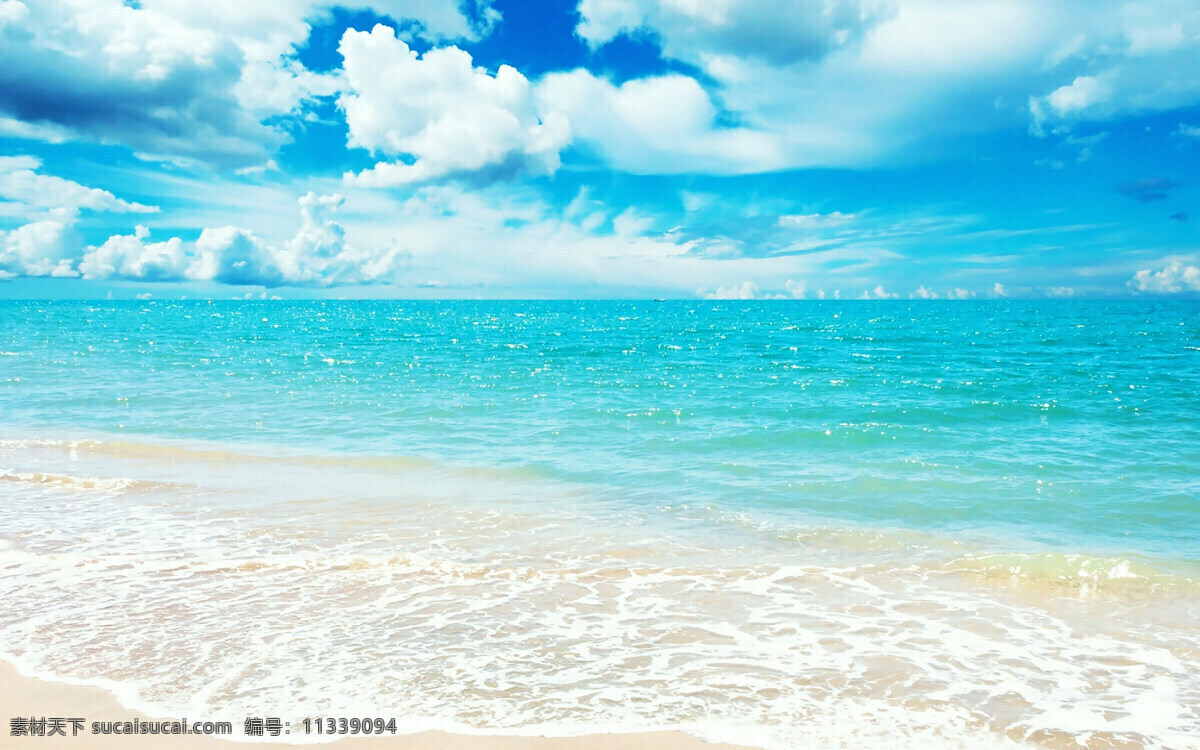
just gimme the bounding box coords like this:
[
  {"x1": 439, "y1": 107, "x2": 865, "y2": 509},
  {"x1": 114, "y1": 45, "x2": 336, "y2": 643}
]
[{"x1": 556, "y1": 0, "x2": 1200, "y2": 174}]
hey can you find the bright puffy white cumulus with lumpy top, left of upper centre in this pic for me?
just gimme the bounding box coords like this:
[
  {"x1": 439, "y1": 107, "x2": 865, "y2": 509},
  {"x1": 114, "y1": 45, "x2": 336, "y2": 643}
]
[{"x1": 338, "y1": 24, "x2": 570, "y2": 186}]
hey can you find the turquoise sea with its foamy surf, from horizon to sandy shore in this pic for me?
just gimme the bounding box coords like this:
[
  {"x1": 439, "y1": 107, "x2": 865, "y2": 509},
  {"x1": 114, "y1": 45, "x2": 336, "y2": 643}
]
[{"x1": 0, "y1": 300, "x2": 1200, "y2": 750}]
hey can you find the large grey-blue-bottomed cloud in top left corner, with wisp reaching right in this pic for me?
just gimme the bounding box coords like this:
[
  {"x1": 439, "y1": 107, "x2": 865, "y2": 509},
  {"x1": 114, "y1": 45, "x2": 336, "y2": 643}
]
[{"x1": 0, "y1": 0, "x2": 498, "y2": 166}]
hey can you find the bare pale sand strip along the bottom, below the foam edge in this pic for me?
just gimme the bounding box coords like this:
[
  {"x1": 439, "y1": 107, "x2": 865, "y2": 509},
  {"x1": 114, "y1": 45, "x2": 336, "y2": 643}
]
[{"x1": 0, "y1": 661, "x2": 736, "y2": 750}]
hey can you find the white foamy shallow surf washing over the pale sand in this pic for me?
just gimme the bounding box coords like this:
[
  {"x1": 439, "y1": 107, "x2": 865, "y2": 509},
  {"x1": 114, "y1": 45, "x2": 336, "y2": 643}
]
[{"x1": 0, "y1": 443, "x2": 1200, "y2": 749}]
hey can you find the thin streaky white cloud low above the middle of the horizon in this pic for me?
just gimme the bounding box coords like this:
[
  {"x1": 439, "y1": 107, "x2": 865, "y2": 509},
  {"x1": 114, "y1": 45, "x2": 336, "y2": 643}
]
[{"x1": 328, "y1": 185, "x2": 835, "y2": 296}]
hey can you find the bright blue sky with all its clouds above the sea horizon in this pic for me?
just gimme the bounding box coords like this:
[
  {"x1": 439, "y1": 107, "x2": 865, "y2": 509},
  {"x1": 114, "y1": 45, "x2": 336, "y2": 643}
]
[{"x1": 0, "y1": 0, "x2": 1200, "y2": 299}]
